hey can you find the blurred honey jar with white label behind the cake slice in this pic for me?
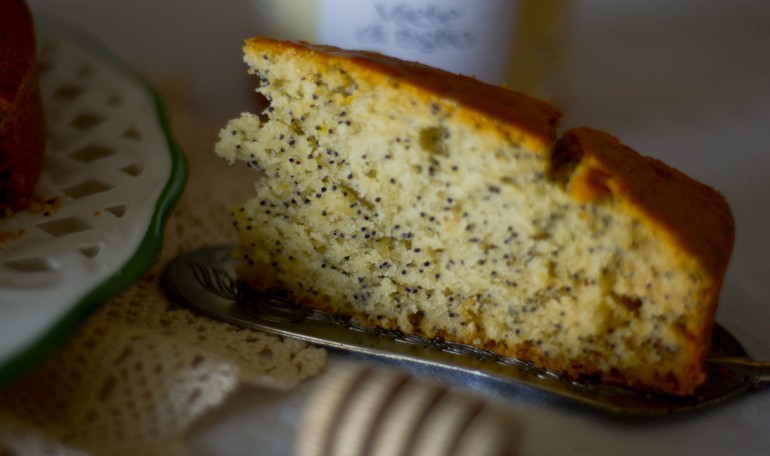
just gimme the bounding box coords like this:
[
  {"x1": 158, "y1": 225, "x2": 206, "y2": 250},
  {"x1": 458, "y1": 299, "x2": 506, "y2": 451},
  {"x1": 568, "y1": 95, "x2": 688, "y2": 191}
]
[{"x1": 250, "y1": 0, "x2": 570, "y2": 101}]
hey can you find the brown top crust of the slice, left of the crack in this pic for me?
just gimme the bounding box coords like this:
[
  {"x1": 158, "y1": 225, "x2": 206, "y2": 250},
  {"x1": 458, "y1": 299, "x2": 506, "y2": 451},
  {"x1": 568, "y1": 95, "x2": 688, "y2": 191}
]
[{"x1": 244, "y1": 37, "x2": 561, "y2": 152}]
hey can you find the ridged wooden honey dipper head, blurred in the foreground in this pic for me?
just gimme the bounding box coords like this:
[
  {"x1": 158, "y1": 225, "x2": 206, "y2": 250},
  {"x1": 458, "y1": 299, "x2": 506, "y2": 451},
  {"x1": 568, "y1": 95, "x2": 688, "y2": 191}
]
[{"x1": 296, "y1": 364, "x2": 516, "y2": 456}]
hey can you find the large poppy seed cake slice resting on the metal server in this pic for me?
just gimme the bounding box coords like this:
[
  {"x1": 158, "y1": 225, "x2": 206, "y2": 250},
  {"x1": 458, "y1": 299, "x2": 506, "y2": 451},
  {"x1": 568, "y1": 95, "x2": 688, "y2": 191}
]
[{"x1": 216, "y1": 38, "x2": 733, "y2": 395}]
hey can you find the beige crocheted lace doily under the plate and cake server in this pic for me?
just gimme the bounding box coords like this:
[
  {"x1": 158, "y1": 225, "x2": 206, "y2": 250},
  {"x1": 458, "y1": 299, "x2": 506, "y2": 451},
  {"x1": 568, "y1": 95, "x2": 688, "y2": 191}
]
[{"x1": 0, "y1": 83, "x2": 326, "y2": 455}]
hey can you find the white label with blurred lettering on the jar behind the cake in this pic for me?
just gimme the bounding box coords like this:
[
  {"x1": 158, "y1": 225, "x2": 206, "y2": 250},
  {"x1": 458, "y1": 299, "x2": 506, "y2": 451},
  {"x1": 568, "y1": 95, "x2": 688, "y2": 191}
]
[{"x1": 318, "y1": 0, "x2": 518, "y2": 84}]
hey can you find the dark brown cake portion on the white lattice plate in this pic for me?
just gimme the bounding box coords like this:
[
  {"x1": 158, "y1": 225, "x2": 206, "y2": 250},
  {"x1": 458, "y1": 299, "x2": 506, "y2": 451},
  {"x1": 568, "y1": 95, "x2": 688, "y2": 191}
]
[{"x1": 0, "y1": 0, "x2": 45, "y2": 217}]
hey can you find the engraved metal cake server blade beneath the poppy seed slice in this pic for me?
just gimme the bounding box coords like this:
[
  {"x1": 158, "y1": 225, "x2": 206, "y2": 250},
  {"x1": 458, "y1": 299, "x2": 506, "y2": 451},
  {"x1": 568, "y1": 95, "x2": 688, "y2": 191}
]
[{"x1": 161, "y1": 245, "x2": 770, "y2": 415}]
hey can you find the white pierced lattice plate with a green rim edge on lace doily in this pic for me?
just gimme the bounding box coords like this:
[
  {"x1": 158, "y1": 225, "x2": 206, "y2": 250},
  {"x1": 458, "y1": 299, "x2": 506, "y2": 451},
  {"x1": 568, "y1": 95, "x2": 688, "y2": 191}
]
[{"x1": 0, "y1": 21, "x2": 186, "y2": 385}]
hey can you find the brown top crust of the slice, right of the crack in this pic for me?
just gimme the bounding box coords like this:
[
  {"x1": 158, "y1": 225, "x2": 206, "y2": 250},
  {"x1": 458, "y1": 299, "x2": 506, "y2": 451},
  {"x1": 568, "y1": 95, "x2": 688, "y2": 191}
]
[{"x1": 554, "y1": 128, "x2": 735, "y2": 288}]
